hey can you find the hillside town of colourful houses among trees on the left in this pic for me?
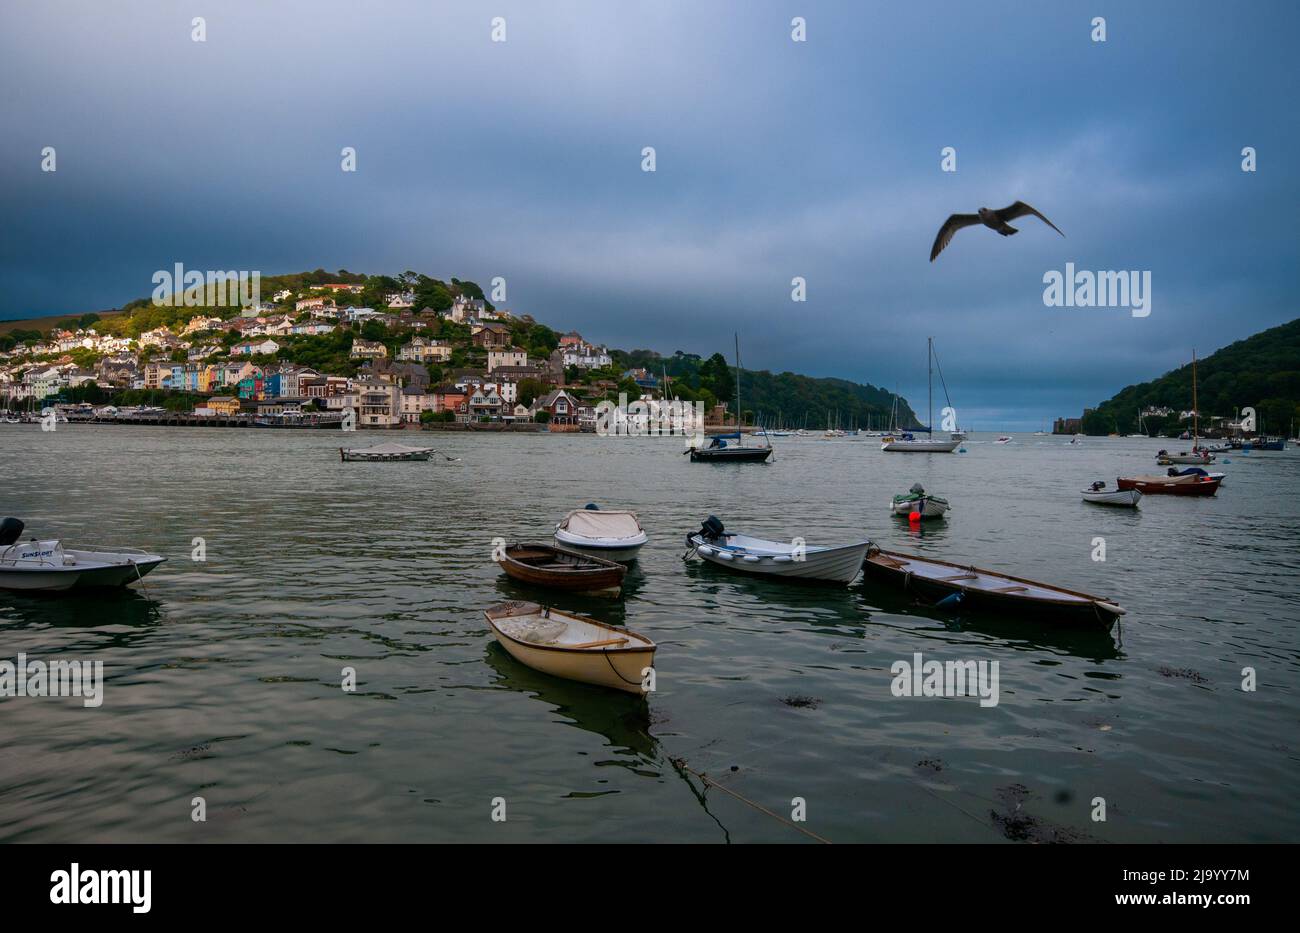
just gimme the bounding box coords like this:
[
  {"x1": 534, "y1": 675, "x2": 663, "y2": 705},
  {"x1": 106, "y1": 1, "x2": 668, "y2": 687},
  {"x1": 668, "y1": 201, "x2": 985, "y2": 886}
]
[{"x1": 0, "y1": 288, "x2": 702, "y2": 431}]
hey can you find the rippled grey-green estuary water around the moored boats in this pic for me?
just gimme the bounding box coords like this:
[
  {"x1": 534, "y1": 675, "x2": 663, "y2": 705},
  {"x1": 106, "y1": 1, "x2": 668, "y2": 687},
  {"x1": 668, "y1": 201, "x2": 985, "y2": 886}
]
[{"x1": 0, "y1": 425, "x2": 1300, "y2": 842}]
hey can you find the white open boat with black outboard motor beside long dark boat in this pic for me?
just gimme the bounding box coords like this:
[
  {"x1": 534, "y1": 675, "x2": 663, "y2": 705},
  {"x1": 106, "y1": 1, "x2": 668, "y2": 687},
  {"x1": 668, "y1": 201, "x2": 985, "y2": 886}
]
[{"x1": 686, "y1": 516, "x2": 871, "y2": 583}]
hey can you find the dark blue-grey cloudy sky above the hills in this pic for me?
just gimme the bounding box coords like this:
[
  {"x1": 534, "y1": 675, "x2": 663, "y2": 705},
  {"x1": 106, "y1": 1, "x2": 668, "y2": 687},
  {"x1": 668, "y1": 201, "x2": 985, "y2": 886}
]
[{"x1": 0, "y1": 0, "x2": 1300, "y2": 429}]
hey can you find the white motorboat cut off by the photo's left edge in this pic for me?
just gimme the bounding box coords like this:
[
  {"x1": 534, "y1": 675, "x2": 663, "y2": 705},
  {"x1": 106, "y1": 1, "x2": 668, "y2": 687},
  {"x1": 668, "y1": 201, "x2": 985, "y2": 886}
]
[{"x1": 0, "y1": 518, "x2": 166, "y2": 593}]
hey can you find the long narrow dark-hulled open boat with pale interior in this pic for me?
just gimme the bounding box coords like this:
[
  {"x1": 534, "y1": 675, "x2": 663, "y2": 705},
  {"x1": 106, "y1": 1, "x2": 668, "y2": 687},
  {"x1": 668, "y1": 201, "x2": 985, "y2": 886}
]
[{"x1": 862, "y1": 544, "x2": 1125, "y2": 632}]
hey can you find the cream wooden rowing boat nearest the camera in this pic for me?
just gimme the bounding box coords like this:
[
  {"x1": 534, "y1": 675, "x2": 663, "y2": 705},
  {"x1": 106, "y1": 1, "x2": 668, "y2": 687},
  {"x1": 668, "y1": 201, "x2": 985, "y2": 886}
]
[{"x1": 484, "y1": 602, "x2": 655, "y2": 697}]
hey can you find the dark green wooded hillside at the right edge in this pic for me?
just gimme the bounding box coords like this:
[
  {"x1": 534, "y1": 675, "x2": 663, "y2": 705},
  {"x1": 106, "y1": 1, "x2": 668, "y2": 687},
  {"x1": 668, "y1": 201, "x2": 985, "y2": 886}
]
[{"x1": 1083, "y1": 320, "x2": 1300, "y2": 435}]
